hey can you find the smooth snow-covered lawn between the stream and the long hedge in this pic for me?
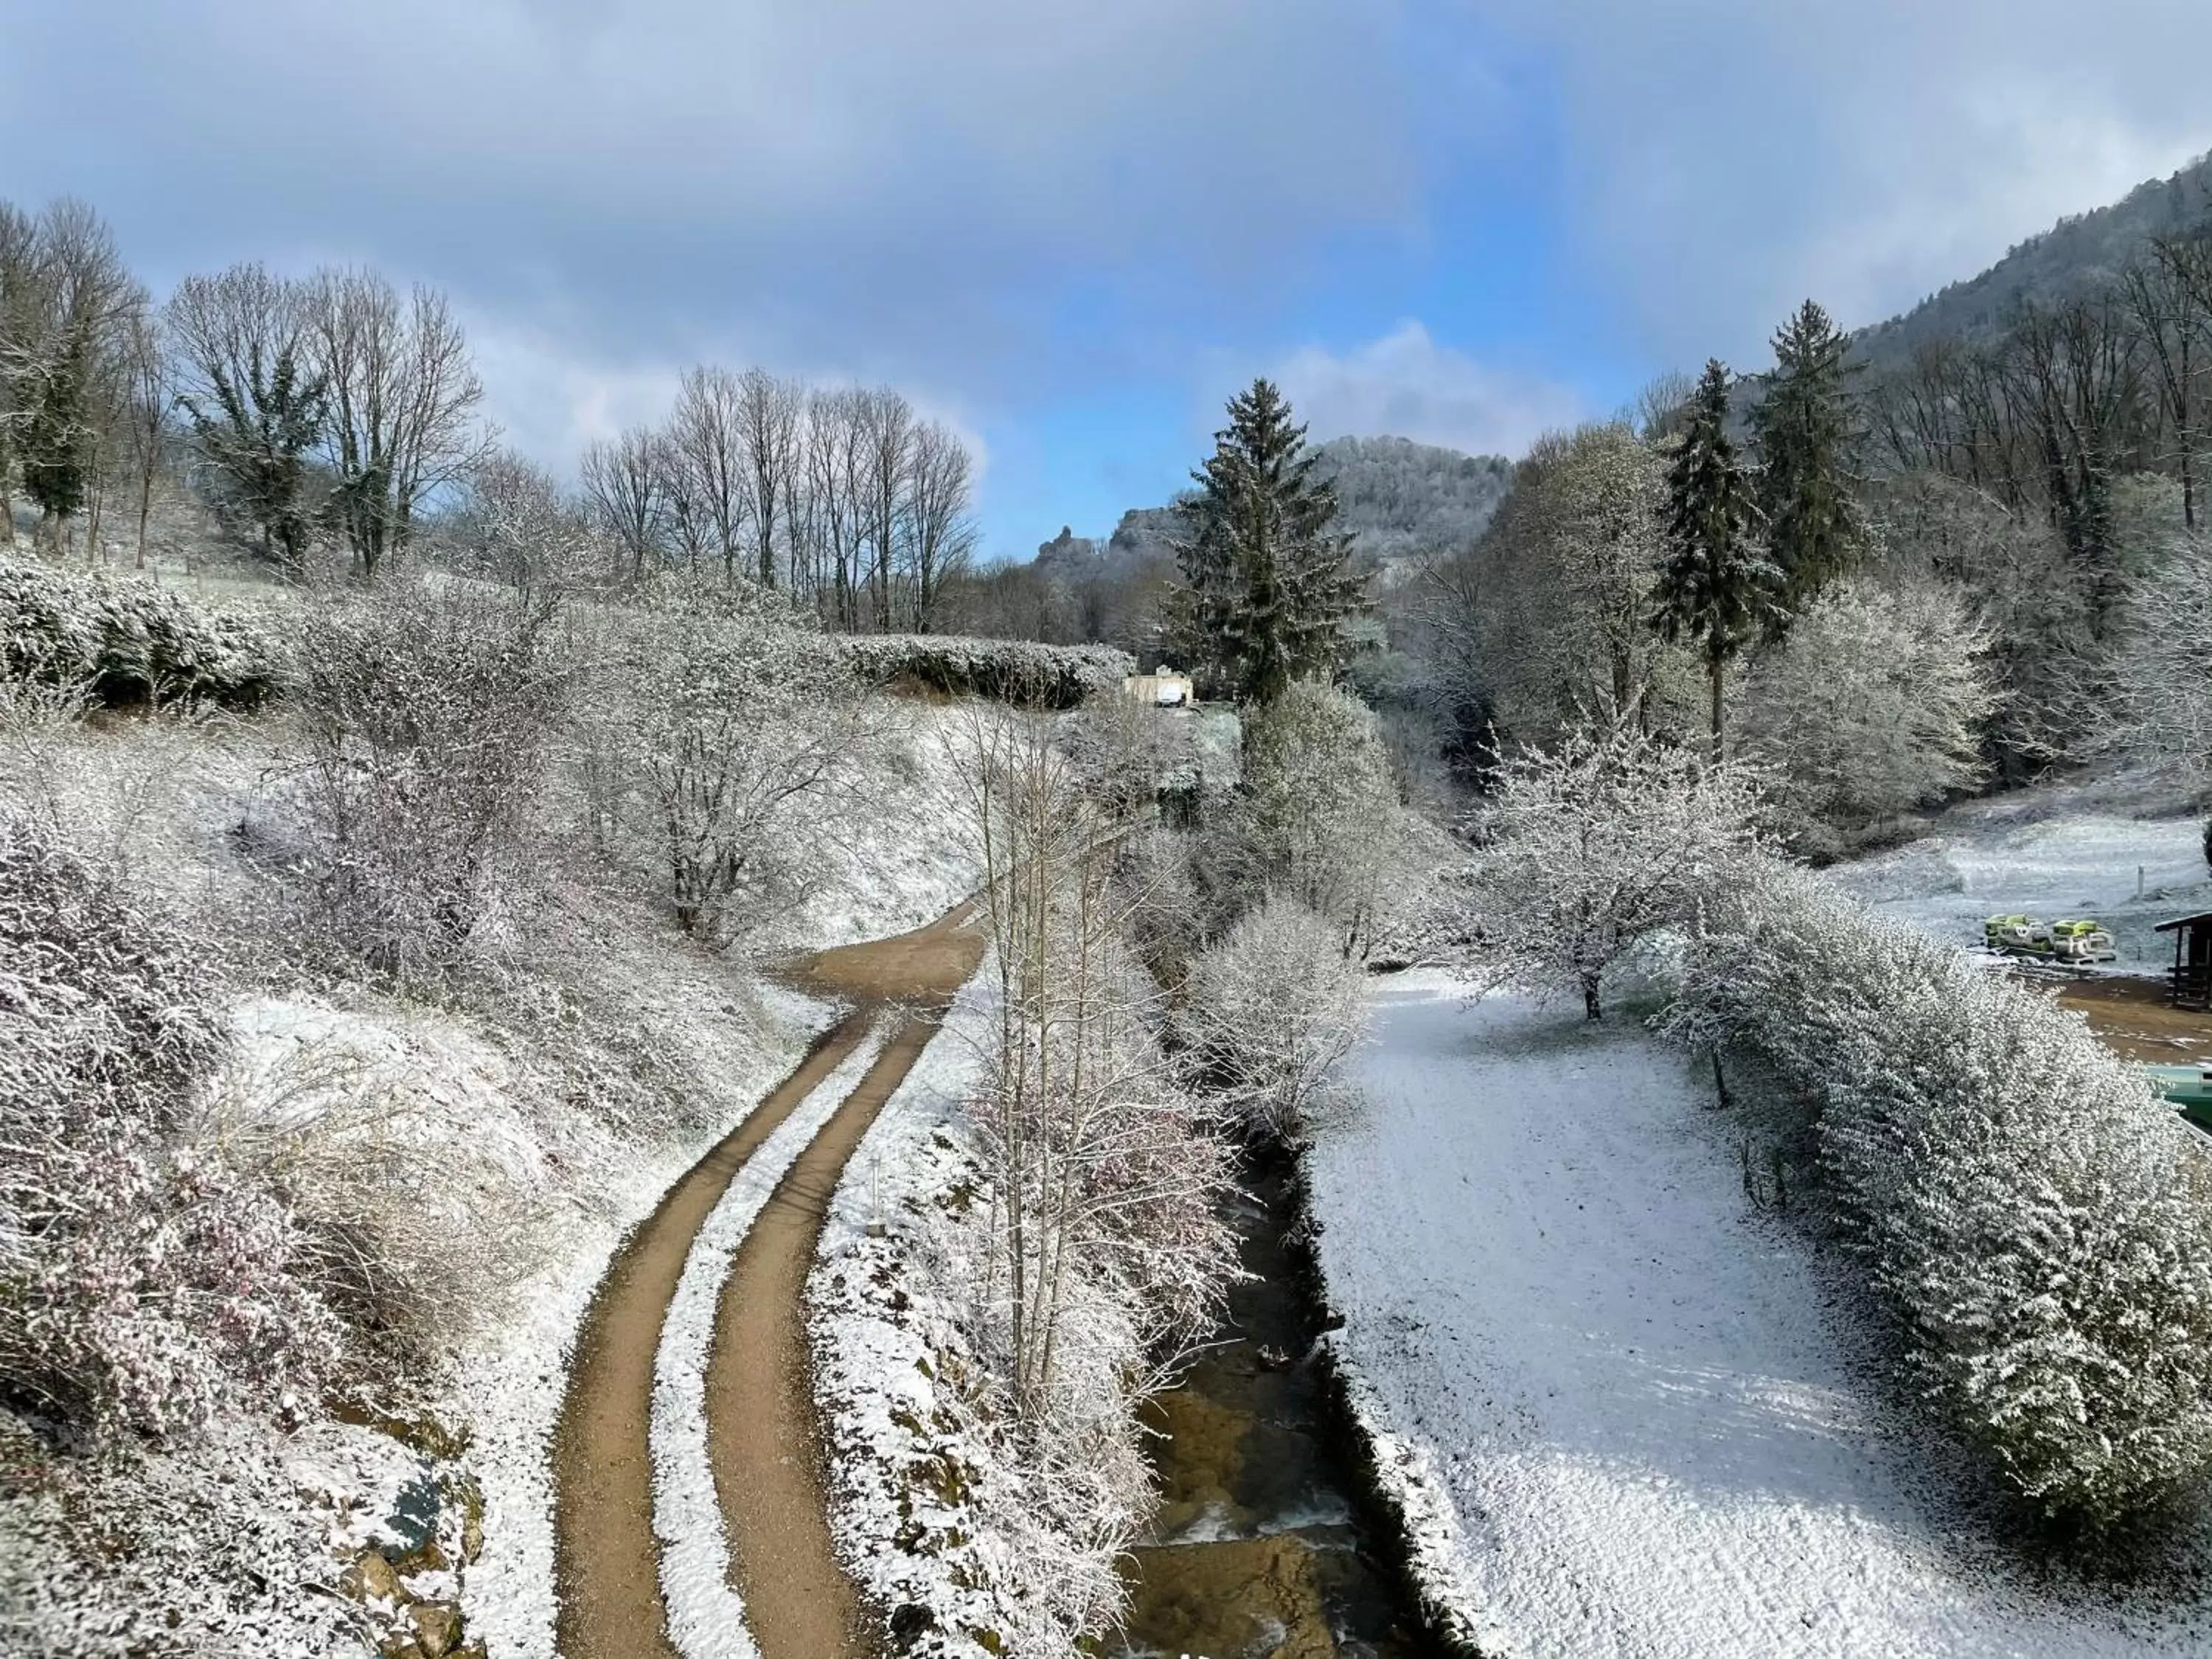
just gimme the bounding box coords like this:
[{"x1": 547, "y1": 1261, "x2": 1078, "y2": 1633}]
[{"x1": 1310, "y1": 973, "x2": 2212, "y2": 1659}]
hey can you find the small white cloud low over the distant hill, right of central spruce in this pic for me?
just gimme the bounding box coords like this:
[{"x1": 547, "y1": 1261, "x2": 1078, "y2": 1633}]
[{"x1": 1274, "y1": 321, "x2": 1584, "y2": 456}]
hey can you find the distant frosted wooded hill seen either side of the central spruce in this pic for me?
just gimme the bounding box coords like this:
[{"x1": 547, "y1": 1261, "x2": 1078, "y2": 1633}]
[{"x1": 1037, "y1": 438, "x2": 1513, "y2": 577}]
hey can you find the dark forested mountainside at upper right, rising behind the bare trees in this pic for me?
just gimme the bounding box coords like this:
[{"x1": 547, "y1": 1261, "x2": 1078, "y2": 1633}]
[{"x1": 1858, "y1": 155, "x2": 2212, "y2": 369}]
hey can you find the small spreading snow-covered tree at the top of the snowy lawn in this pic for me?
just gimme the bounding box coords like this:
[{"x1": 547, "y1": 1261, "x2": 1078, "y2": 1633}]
[{"x1": 1475, "y1": 719, "x2": 1765, "y2": 1020}]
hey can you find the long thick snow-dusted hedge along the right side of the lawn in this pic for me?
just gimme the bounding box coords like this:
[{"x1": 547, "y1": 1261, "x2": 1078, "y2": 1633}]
[{"x1": 1666, "y1": 865, "x2": 2212, "y2": 1524}]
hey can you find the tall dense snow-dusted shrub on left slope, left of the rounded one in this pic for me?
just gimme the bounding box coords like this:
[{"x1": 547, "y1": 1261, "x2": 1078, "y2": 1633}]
[{"x1": 294, "y1": 582, "x2": 568, "y2": 980}]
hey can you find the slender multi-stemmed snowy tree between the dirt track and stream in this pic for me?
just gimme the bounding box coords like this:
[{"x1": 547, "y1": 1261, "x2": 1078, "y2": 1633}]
[{"x1": 956, "y1": 710, "x2": 1232, "y2": 1422}]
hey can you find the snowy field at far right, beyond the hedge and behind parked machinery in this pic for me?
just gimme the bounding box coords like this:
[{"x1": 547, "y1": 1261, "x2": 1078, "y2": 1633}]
[{"x1": 1827, "y1": 779, "x2": 2212, "y2": 971}]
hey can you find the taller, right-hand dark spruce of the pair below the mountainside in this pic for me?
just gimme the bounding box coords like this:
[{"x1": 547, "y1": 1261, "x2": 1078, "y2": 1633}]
[{"x1": 1752, "y1": 301, "x2": 1867, "y2": 624}]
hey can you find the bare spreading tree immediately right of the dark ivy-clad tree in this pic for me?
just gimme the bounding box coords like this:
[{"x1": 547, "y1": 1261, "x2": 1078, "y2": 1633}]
[{"x1": 305, "y1": 270, "x2": 491, "y2": 584}]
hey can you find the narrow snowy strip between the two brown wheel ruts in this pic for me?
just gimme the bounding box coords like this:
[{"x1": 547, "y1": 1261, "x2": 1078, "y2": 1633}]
[{"x1": 653, "y1": 1020, "x2": 891, "y2": 1659}]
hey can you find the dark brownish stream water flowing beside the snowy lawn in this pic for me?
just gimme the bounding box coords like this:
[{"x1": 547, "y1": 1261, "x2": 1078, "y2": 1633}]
[{"x1": 1108, "y1": 1152, "x2": 1433, "y2": 1659}]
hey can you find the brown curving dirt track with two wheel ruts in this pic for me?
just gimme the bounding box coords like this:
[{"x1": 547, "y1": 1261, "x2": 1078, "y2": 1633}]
[{"x1": 553, "y1": 905, "x2": 982, "y2": 1659}]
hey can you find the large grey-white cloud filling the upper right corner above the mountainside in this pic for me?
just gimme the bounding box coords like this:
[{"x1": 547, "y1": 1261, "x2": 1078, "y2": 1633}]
[{"x1": 1478, "y1": 0, "x2": 2212, "y2": 365}]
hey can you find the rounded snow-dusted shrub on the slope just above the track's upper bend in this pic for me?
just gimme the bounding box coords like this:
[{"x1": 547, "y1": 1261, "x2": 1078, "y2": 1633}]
[{"x1": 599, "y1": 584, "x2": 878, "y2": 942}]
